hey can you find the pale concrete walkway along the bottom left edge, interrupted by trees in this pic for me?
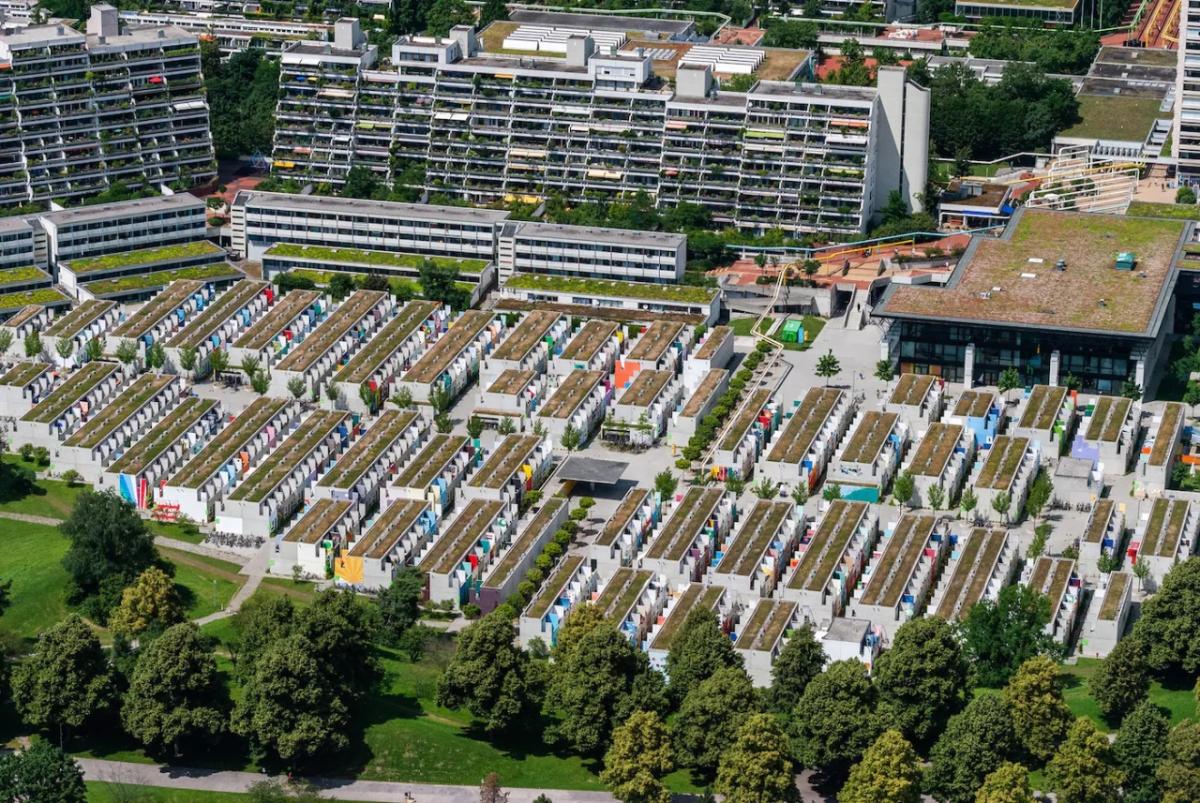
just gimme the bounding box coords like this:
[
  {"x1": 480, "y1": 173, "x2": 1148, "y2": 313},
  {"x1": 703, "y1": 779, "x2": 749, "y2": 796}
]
[{"x1": 78, "y1": 759, "x2": 616, "y2": 803}]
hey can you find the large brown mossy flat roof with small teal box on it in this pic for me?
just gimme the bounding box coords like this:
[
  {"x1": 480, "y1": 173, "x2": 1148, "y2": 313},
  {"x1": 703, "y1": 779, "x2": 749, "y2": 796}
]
[{"x1": 878, "y1": 208, "x2": 1192, "y2": 336}]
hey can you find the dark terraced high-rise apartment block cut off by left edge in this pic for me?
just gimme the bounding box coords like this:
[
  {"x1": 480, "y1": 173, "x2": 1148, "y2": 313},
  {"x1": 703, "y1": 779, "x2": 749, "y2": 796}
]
[{"x1": 0, "y1": 5, "x2": 216, "y2": 205}]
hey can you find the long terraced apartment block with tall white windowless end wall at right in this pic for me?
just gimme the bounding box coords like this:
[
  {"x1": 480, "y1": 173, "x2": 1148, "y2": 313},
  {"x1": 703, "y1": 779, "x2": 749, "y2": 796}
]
[{"x1": 274, "y1": 26, "x2": 929, "y2": 234}]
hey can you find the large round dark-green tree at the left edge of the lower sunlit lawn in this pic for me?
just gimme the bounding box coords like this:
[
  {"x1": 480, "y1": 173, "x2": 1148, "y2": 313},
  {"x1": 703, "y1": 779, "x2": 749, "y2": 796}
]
[{"x1": 230, "y1": 634, "x2": 350, "y2": 767}]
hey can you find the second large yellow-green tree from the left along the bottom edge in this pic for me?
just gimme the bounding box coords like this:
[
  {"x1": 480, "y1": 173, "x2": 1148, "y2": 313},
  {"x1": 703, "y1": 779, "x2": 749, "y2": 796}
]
[{"x1": 714, "y1": 714, "x2": 800, "y2": 803}]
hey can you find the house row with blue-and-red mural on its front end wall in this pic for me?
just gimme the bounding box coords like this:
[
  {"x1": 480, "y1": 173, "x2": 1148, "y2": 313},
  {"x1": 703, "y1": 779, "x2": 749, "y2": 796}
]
[{"x1": 97, "y1": 396, "x2": 221, "y2": 509}]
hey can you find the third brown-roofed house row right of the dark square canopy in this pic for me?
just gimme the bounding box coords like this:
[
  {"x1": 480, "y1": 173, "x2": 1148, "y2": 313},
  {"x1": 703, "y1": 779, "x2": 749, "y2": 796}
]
[{"x1": 713, "y1": 499, "x2": 805, "y2": 605}]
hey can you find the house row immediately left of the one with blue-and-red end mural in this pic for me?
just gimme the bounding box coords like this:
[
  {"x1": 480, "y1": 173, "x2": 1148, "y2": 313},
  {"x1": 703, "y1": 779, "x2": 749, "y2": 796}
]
[{"x1": 54, "y1": 373, "x2": 184, "y2": 485}]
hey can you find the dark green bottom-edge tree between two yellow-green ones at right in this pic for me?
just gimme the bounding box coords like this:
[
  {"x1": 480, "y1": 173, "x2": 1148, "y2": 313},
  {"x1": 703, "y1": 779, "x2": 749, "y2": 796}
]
[{"x1": 925, "y1": 694, "x2": 1020, "y2": 803}]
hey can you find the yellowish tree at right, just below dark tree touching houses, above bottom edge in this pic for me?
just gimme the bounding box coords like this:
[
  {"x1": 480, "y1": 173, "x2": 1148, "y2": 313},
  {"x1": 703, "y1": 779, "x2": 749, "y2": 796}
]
[{"x1": 1004, "y1": 655, "x2": 1072, "y2": 761}]
